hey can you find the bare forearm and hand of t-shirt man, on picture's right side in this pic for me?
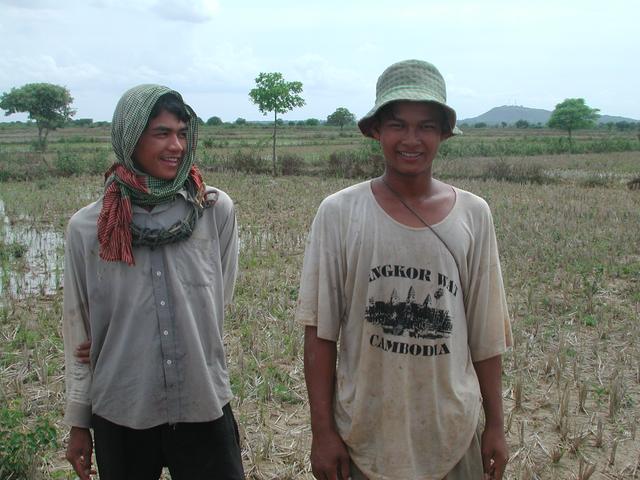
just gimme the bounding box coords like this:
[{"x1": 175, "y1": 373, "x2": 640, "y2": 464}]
[{"x1": 473, "y1": 355, "x2": 509, "y2": 480}]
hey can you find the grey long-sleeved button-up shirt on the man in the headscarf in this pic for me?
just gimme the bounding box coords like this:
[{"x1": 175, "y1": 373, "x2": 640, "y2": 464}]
[{"x1": 63, "y1": 187, "x2": 238, "y2": 428}]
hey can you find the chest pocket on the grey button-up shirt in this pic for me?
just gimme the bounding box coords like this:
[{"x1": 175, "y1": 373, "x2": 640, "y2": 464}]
[{"x1": 176, "y1": 236, "x2": 221, "y2": 287}]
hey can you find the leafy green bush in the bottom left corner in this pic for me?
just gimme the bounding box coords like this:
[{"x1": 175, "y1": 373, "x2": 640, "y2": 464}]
[{"x1": 0, "y1": 407, "x2": 57, "y2": 480}]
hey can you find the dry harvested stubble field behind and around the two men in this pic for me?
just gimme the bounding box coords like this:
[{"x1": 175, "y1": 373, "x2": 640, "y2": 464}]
[{"x1": 0, "y1": 149, "x2": 640, "y2": 479}]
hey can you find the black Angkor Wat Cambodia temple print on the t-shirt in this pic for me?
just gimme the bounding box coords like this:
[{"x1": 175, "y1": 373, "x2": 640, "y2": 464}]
[{"x1": 365, "y1": 265, "x2": 458, "y2": 356}]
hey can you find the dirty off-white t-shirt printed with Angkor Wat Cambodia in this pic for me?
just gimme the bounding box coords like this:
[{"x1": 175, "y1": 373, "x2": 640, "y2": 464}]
[{"x1": 296, "y1": 182, "x2": 511, "y2": 480}]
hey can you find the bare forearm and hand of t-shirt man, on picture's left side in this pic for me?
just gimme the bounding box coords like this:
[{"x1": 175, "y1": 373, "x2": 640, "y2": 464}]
[{"x1": 304, "y1": 326, "x2": 349, "y2": 480}]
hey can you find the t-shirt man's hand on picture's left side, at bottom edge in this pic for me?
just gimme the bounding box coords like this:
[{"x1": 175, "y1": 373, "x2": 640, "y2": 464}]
[{"x1": 311, "y1": 430, "x2": 349, "y2": 480}]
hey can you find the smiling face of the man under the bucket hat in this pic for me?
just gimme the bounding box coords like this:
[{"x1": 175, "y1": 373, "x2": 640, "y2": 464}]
[{"x1": 372, "y1": 101, "x2": 446, "y2": 176}]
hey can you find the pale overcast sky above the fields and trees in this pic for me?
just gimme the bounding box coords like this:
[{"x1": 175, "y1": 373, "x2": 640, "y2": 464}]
[{"x1": 0, "y1": 0, "x2": 640, "y2": 121}]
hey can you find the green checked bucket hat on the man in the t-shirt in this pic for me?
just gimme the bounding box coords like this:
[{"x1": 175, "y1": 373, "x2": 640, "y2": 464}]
[{"x1": 358, "y1": 60, "x2": 462, "y2": 137}]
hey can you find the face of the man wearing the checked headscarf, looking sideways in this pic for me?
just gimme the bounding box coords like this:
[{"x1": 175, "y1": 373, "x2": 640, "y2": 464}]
[{"x1": 133, "y1": 110, "x2": 188, "y2": 180}]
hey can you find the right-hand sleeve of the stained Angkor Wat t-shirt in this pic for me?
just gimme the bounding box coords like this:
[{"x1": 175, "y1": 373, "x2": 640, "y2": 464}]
[{"x1": 465, "y1": 206, "x2": 512, "y2": 362}]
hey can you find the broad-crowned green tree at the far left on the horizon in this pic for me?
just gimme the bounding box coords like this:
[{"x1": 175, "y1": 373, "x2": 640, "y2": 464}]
[{"x1": 0, "y1": 83, "x2": 76, "y2": 152}]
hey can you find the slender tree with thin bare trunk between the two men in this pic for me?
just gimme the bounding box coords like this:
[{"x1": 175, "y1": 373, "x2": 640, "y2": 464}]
[{"x1": 249, "y1": 72, "x2": 305, "y2": 176}]
